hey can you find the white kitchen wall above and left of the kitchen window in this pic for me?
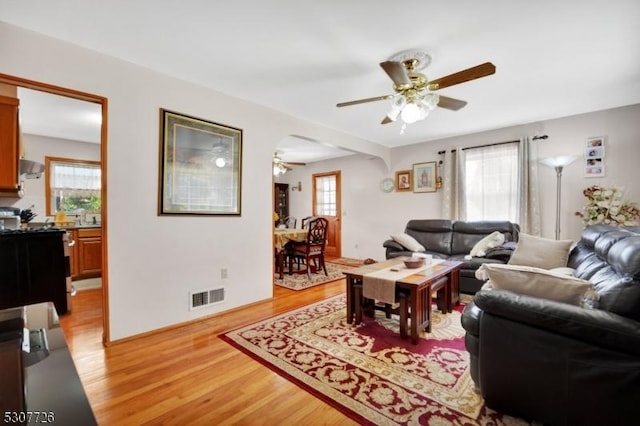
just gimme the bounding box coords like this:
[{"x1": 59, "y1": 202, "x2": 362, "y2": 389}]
[{"x1": 0, "y1": 133, "x2": 100, "y2": 222}]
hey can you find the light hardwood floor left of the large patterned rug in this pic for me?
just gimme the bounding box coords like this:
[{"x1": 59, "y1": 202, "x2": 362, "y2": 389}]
[{"x1": 61, "y1": 279, "x2": 357, "y2": 425}]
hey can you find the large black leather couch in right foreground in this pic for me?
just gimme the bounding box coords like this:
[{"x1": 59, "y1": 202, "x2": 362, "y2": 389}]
[{"x1": 462, "y1": 225, "x2": 640, "y2": 426}]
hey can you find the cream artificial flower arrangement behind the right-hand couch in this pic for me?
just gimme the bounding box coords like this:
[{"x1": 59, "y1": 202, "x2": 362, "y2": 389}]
[{"x1": 576, "y1": 185, "x2": 640, "y2": 226}]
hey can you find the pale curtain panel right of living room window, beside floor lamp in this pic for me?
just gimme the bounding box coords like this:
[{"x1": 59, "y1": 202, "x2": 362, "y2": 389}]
[{"x1": 518, "y1": 137, "x2": 541, "y2": 235}]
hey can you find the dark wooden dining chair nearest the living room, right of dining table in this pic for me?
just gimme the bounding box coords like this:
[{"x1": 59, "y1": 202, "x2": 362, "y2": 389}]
[{"x1": 287, "y1": 217, "x2": 329, "y2": 280}]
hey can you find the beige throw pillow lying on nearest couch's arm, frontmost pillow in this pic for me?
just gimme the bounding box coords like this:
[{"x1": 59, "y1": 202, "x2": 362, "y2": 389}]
[{"x1": 479, "y1": 263, "x2": 597, "y2": 307}]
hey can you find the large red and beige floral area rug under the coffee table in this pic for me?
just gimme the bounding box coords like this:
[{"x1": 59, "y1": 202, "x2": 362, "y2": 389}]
[{"x1": 220, "y1": 295, "x2": 528, "y2": 425}]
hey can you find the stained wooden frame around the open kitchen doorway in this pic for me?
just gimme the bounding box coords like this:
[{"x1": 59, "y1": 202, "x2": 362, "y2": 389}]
[{"x1": 0, "y1": 74, "x2": 110, "y2": 345}]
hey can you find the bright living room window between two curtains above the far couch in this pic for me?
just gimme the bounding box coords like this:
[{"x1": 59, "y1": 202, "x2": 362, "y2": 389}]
[{"x1": 464, "y1": 142, "x2": 518, "y2": 223}]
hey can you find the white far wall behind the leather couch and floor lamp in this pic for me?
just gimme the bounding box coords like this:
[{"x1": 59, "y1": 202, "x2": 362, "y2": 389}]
[{"x1": 280, "y1": 105, "x2": 640, "y2": 260}]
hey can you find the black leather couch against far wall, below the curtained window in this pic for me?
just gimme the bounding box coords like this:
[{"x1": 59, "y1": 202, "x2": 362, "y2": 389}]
[{"x1": 382, "y1": 219, "x2": 520, "y2": 294}]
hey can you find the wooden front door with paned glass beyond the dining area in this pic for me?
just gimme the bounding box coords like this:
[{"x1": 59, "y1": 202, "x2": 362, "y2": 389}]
[{"x1": 312, "y1": 171, "x2": 342, "y2": 257}]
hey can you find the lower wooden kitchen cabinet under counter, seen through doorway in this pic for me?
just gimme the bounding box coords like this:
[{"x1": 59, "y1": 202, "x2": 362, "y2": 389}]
[{"x1": 69, "y1": 228, "x2": 102, "y2": 280}]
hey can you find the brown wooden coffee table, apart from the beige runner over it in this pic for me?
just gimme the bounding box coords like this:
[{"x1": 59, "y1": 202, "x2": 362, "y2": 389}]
[{"x1": 344, "y1": 256, "x2": 462, "y2": 344}]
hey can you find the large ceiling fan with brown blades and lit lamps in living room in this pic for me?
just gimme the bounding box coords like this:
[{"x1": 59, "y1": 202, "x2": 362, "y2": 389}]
[{"x1": 336, "y1": 50, "x2": 496, "y2": 124}]
